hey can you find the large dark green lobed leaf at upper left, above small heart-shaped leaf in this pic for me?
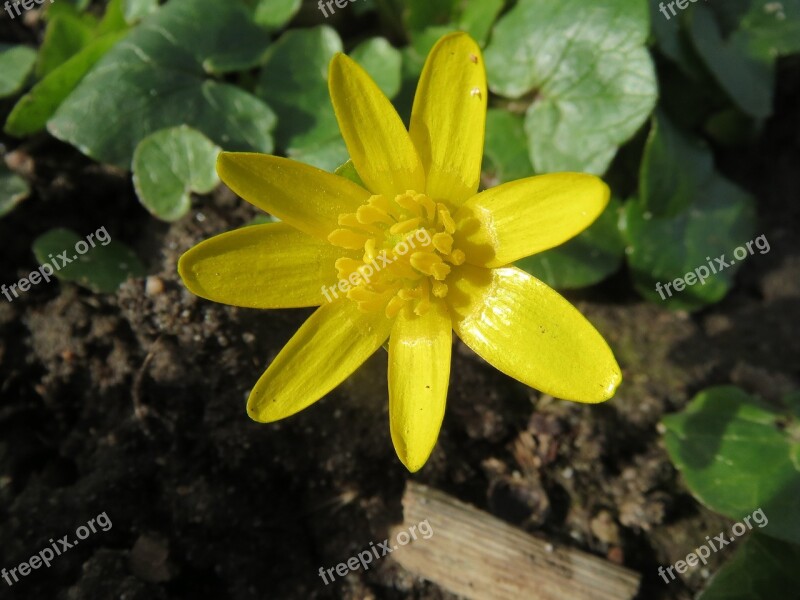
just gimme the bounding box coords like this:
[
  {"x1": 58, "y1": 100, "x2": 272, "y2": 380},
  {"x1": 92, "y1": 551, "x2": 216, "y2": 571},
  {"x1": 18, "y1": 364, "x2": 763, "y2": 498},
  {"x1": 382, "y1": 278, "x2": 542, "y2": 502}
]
[{"x1": 47, "y1": 0, "x2": 275, "y2": 168}]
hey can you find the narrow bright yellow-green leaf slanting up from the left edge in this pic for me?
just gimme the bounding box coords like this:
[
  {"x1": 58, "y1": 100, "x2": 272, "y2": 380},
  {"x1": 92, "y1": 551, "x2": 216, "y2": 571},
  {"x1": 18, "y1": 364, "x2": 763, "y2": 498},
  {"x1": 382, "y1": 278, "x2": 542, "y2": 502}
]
[{"x1": 5, "y1": 32, "x2": 126, "y2": 137}]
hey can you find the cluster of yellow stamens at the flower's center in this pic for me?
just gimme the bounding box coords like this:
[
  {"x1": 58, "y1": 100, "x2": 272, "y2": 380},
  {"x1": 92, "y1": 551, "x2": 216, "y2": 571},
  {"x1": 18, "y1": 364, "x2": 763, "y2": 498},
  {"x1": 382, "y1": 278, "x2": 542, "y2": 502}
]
[{"x1": 328, "y1": 190, "x2": 464, "y2": 318}]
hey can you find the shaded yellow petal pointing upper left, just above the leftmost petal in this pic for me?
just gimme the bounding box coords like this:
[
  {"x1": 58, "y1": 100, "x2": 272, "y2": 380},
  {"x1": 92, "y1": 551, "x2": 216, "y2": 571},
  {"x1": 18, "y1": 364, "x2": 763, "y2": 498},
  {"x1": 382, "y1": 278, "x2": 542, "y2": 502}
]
[{"x1": 217, "y1": 152, "x2": 370, "y2": 240}]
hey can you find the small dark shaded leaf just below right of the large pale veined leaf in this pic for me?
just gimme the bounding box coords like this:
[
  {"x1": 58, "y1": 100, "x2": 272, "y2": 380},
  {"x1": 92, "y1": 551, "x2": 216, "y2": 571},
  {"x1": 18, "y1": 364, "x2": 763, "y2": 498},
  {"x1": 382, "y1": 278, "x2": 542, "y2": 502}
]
[{"x1": 639, "y1": 112, "x2": 714, "y2": 217}]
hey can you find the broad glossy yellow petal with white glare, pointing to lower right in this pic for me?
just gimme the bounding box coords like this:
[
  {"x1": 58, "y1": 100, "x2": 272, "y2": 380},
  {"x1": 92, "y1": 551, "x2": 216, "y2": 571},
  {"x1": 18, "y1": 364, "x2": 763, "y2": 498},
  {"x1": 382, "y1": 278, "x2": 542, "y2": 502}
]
[{"x1": 446, "y1": 265, "x2": 622, "y2": 402}]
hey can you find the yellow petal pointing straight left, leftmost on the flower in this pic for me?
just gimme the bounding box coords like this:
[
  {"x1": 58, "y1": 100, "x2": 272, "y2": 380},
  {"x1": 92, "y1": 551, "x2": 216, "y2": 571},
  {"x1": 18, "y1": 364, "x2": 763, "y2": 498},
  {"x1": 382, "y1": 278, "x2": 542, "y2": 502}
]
[{"x1": 178, "y1": 223, "x2": 356, "y2": 308}]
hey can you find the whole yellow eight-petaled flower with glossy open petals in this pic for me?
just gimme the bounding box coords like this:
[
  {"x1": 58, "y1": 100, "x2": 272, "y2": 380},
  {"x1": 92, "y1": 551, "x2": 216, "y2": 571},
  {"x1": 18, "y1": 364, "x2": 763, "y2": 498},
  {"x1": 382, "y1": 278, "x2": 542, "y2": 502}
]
[{"x1": 178, "y1": 33, "x2": 621, "y2": 472}]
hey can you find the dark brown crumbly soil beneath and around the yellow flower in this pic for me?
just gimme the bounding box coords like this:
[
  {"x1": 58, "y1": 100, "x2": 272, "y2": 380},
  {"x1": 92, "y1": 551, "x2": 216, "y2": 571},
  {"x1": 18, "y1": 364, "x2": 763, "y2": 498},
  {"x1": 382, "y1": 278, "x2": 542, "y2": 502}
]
[{"x1": 0, "y1": 27, "x2": 800, "y2": 600}]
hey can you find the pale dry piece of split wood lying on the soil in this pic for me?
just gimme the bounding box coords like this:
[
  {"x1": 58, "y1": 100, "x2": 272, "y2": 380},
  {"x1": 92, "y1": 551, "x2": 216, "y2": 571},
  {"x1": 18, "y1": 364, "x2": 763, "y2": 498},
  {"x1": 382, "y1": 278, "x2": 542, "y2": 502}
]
[{"x1": 391, "y1": 482, "x2": 640, "y2": 600}]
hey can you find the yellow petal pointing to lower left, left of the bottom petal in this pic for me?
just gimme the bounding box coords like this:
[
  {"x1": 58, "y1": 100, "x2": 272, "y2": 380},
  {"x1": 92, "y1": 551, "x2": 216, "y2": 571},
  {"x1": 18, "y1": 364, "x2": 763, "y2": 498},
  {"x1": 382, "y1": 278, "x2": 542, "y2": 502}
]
[{"x1": 247, "y1": 299, "x2": 391, "y2": 423}]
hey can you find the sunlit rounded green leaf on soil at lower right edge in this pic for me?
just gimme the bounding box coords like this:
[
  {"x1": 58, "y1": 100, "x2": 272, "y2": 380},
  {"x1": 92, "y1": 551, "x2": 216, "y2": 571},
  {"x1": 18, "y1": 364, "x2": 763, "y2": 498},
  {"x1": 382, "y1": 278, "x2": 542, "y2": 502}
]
[{"x1": 663, "y1": 386, "x2": 800, "y2": 544}]
